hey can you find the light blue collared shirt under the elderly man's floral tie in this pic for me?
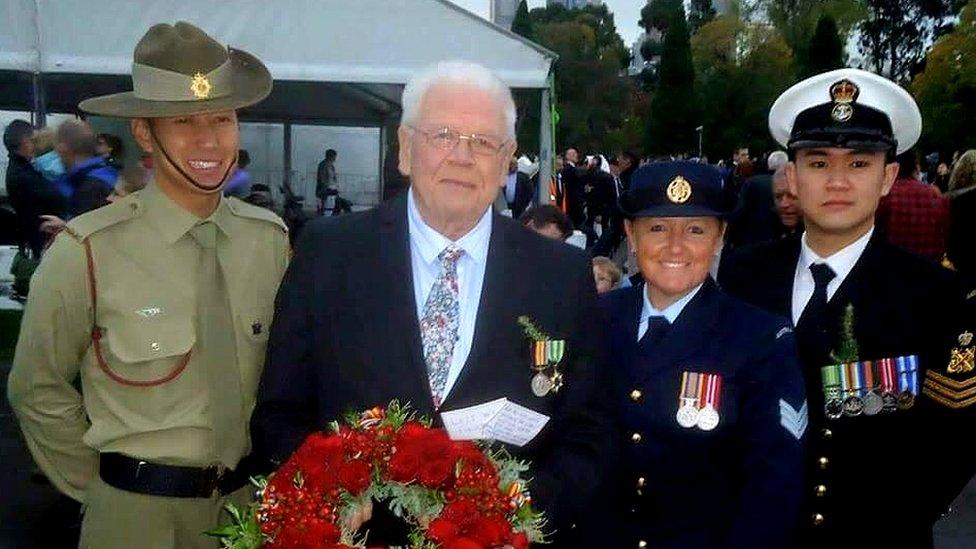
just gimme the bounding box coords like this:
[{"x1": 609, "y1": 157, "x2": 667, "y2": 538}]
[{"x1": 407, "y1": 188, "x2": 491, "y2": 398}]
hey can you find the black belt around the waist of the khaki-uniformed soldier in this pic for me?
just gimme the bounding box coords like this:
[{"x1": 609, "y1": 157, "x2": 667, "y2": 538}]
[{"x1": 99, "y1": 454, "x2": 249, "y2": 498}]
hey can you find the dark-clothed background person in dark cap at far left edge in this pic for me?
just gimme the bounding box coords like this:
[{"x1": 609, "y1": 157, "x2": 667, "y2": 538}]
[{"x1": 3, "y1": 120, "x2": 65, "y2": 260}]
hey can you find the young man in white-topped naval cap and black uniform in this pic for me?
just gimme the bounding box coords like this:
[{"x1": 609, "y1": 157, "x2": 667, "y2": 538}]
[{"x1": 723, "y1": 69, "x2": 976, "y2": 548}]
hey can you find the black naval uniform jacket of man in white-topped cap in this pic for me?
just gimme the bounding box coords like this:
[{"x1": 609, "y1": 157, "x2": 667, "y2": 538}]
[{"x1": 721, "y1": 232, "x2": 972, "y2": 547}]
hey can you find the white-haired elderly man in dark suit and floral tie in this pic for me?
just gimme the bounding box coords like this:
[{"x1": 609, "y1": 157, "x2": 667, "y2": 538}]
[{"x1": 251, "y1": 62, "x2": 611, "y2": 545}]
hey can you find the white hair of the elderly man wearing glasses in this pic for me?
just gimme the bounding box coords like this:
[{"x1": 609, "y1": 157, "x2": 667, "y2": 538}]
[{"x1": 400, "y1": 61, "x2": 515, "y2": 139}]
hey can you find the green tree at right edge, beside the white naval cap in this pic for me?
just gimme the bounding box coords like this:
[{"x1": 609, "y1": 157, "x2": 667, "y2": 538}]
[{"x1": 911, "y1": 0, "x2": 976, "y2": 156}]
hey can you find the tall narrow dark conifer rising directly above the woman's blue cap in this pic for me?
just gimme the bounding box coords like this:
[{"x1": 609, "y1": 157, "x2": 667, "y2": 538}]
[{"x1": 644, "y1": 0, "x2": 700, "y2": 154}]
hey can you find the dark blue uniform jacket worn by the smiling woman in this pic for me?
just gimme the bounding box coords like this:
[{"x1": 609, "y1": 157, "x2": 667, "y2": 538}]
[{"x1": 586, "y1": 278, "x2": 807, "y2": 549}]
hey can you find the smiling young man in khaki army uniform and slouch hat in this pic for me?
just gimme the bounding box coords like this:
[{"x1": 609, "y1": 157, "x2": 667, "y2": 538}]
[{"x1": 8, "y1": 22, "x2": 288, "y2": 549}]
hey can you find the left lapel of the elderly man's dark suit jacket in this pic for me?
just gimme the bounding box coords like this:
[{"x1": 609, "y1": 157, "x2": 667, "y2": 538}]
[{"x1": 373, "y1": 193, "x2": 433, "y2": 410}]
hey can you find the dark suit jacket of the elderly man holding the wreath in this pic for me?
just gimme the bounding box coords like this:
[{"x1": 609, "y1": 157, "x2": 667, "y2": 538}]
[{"x1": 251, "y1": 194, "x2": 612, "y2": 540}]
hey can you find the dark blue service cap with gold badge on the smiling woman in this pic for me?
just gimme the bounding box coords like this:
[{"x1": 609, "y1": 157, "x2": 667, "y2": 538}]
[{"x1": 619, "y1": 161, "x2": 735, "y2": 218}]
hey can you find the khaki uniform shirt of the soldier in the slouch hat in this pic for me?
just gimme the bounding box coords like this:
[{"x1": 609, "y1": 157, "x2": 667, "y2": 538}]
[{"x1": 8, "y1": 184, "x2": 289, "y2": 500}]
